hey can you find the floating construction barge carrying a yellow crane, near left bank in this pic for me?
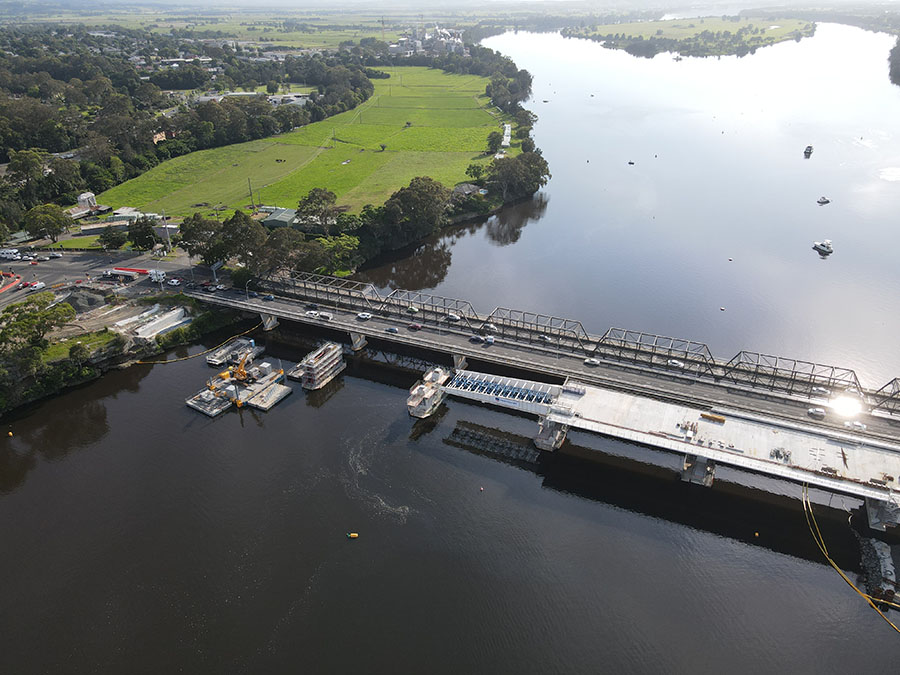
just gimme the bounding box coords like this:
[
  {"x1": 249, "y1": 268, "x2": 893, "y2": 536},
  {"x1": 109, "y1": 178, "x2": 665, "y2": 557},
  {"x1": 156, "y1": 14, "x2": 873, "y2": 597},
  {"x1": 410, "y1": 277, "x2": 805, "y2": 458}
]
[{"x1": 185, "y1": 348, "x2": 291, "y2": 417}]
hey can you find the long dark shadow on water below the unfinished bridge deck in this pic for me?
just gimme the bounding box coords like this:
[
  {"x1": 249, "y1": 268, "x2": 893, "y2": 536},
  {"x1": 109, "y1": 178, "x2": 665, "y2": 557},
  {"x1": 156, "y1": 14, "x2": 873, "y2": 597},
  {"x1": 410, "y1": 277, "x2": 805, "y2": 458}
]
[{"x1": 432, "y1": 420, "x2": 865, "y2": 572}]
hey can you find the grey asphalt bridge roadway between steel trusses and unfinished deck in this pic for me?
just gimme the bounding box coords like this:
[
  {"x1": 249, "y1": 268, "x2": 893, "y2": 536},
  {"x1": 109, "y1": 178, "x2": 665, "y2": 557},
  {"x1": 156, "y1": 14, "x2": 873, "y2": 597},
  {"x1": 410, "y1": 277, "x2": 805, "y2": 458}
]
[{"x1": 191, "y1": 290, "x2": 900, "y2": 444}]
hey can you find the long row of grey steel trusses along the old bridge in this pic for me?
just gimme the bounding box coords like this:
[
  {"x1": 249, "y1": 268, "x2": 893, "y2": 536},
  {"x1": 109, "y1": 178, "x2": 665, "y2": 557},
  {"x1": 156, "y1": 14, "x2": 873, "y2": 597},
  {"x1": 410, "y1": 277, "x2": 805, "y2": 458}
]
[{"x1": 243, "y1": 272, "x2": 900, "y2": 415}]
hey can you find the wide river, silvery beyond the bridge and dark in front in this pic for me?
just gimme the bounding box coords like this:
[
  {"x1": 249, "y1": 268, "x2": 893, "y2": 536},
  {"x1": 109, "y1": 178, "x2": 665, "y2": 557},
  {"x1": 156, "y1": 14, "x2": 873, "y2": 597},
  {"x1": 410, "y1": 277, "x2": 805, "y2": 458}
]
[{"x1": 0, "y1": 26, "x2": 900, "y2": 674}]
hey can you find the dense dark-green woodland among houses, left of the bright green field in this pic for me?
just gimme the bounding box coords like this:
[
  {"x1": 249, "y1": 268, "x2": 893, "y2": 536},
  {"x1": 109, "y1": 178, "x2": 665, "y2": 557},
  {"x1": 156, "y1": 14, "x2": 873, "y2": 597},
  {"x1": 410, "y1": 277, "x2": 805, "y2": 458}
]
[{"x1": 0, "y1": 25, "x2": 379, "y2": 226}]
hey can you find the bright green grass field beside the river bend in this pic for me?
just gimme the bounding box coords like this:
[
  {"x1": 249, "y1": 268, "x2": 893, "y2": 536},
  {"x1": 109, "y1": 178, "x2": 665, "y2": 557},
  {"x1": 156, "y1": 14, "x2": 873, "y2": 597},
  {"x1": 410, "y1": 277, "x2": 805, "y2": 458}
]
[{"x1": 97, "y1": 67, "x2": 518, "y2": 216}]
